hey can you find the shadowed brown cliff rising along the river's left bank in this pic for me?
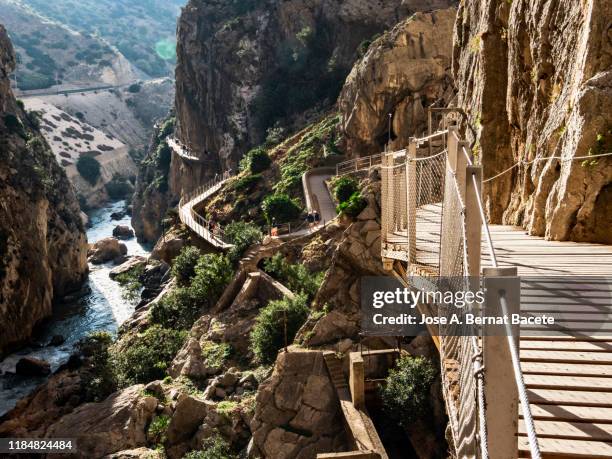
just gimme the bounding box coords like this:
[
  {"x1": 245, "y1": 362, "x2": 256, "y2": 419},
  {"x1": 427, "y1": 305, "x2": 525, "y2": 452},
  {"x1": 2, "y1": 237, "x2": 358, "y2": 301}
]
[{"x1": 0, "y1": 26, "x2": 87, "y2": 355}]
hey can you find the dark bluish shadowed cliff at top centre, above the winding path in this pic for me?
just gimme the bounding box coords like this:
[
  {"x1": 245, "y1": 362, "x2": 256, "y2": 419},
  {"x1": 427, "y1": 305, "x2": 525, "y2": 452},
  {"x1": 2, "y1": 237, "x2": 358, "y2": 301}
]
[{"x1": 176, "y1": 0, "x2": 453, "y2": 183}]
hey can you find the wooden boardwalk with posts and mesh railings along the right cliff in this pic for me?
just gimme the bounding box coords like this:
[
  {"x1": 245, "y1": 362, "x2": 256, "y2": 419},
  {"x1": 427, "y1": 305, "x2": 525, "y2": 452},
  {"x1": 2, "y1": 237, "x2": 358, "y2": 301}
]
[{"x1": 337, "y1": 127, "x2": 612, "y2": 459}]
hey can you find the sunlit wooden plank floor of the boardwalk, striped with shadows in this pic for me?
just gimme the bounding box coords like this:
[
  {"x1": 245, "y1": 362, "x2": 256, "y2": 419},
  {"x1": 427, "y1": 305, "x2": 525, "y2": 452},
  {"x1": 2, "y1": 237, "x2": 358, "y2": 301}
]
[{"x1": 393, "y1": 205, "x2": 612, "y2": 459}]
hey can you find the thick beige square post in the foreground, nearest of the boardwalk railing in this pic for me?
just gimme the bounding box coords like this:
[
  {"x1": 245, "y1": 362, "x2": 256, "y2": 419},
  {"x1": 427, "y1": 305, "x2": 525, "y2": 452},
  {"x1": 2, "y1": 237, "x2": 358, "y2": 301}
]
[{"x1": 482, "y1": 267, "x2": 521, "y2": 459}]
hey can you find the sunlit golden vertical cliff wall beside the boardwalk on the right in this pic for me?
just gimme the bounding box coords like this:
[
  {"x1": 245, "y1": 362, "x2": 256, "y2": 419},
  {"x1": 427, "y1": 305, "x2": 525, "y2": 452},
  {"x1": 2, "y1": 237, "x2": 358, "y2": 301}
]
[{"x1": 453, "y1": 0, "x2": 612, "y2": 243}]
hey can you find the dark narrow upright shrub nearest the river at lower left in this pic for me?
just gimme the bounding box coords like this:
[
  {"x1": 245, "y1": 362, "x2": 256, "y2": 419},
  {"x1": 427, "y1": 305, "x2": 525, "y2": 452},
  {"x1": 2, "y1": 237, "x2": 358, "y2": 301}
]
[{"x1": 77, "y1": 331, "x2": 117, "y2": 402}]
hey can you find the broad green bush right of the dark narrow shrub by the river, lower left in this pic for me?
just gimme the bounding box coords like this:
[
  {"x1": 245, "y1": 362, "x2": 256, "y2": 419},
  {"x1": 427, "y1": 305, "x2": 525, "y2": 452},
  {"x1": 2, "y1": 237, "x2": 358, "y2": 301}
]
[{"x1": 111, "y1": 325, "x2": 187, "y2": 387}]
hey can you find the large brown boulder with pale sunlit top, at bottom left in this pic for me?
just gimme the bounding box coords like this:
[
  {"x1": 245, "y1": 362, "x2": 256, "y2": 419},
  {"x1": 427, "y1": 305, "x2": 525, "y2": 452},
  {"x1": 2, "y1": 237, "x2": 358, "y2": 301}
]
[{"x1": 46, "y1": 384, "x2": 158, "y2": 458}]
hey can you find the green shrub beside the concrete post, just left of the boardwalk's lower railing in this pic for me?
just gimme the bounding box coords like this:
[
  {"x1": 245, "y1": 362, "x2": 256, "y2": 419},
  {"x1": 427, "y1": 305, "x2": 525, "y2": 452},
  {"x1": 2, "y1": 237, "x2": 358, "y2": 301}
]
[{"x1": 380, "y1": 356, "x2": 437, "y2": 428}]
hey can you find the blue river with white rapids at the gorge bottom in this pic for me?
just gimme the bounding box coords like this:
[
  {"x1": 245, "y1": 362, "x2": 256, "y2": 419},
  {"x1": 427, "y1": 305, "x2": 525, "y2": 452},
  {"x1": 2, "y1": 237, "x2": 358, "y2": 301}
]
[{"x1": 0, "y1": 201, "x2": 149, "y2": 416}]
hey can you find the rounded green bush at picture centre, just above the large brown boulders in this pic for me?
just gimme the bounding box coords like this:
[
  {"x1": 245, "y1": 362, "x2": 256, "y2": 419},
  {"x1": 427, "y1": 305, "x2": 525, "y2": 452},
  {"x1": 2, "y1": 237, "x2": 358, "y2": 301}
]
[{"x1": 251, "y1": 295, "x2": 309, "y2": 364}]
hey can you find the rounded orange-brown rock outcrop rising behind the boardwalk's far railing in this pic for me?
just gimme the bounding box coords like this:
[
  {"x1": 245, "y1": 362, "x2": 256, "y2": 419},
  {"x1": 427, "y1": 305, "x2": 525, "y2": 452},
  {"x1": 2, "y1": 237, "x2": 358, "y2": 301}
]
[{"x1": 338, "y1": 7, "x2": 456, "y2": 156}]
